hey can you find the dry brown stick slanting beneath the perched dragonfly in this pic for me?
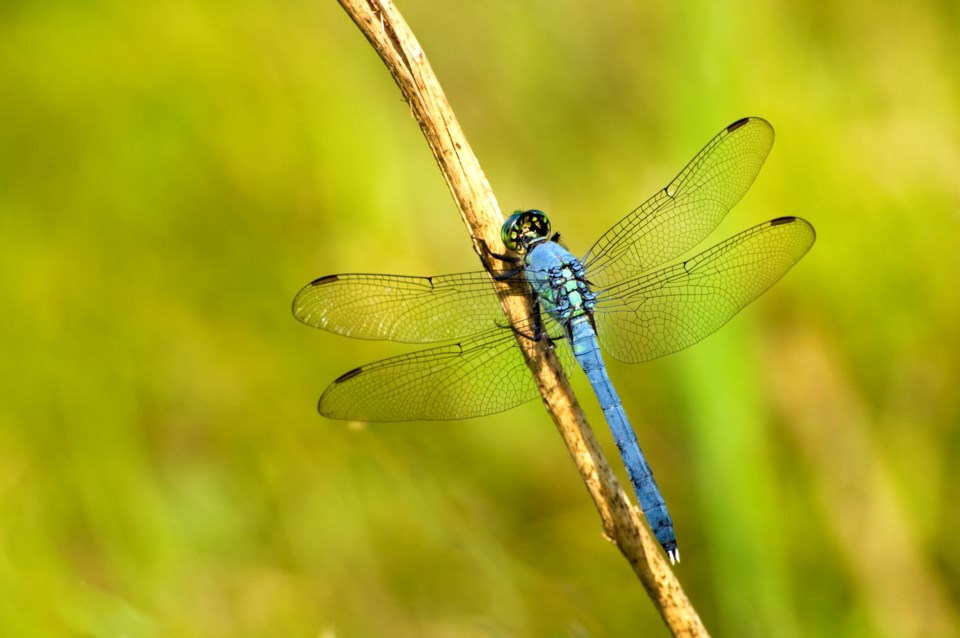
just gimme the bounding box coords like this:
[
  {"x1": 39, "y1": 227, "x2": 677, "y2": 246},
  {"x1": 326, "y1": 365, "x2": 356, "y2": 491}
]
[{"x1": 338, "y1": 0, "x2": 708, "y2": 636}]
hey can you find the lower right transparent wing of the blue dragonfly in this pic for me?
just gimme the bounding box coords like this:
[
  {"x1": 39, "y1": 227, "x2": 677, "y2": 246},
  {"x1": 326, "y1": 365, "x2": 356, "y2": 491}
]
[{"x1": 594, "y1": 217, "x2": 816, "y2": 363}]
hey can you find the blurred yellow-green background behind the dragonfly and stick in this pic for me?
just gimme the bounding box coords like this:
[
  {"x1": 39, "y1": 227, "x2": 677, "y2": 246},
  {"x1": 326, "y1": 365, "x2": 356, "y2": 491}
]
[{"x1": 0, "y1": 0, "x2": 960, "y2": 638}]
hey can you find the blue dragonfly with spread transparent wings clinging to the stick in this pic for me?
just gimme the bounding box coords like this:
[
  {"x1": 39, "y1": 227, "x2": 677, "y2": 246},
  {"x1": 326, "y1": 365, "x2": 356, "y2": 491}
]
[{"x1": 293, "y1": 117, "x2": 816, "y2": 562}]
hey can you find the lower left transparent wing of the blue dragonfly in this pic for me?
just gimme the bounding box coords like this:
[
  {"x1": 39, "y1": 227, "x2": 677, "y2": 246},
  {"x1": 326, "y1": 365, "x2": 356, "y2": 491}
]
[{"x1": 318, "y1": 322, "x2": 573, "y2": 421}]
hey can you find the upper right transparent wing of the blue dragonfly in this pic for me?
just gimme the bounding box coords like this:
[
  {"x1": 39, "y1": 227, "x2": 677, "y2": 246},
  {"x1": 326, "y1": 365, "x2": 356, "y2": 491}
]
[{"x1": 583, "y1": 117, "x2": 773, "y2": 287}]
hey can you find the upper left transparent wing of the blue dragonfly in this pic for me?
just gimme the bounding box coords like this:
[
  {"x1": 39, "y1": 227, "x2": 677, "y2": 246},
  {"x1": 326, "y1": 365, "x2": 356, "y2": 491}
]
[{"x1": 293, "y1": 272, "x2": 523, "y2": 343}]
